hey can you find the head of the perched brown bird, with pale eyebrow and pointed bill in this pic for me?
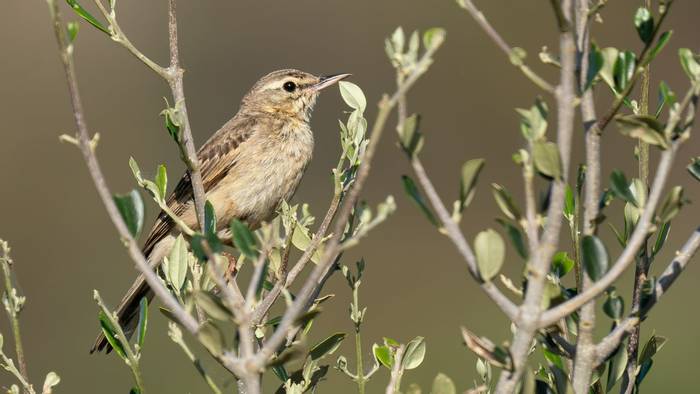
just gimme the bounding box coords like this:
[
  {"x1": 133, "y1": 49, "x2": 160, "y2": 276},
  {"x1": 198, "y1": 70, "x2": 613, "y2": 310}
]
[{"x1": 241, "y1": 69, "x2": 350, "y2": 120}]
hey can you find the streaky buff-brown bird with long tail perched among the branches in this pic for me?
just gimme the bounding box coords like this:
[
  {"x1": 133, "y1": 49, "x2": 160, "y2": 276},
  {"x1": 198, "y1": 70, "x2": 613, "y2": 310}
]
[{"x1": 90, "y1": 69, "x2": 350, "y2": 353}]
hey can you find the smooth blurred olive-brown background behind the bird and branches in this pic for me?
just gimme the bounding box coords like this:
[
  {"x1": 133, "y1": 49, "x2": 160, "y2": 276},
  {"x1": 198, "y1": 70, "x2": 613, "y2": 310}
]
[{"x1": 0, "y1": 0, "x2": 700, "y2": 393}]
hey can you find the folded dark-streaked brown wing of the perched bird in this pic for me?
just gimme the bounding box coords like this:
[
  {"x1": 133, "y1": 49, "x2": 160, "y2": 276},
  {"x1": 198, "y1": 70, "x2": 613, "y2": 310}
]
[{"x1": 143, "y1": 116, "x2": 257, "y2": 256}]
